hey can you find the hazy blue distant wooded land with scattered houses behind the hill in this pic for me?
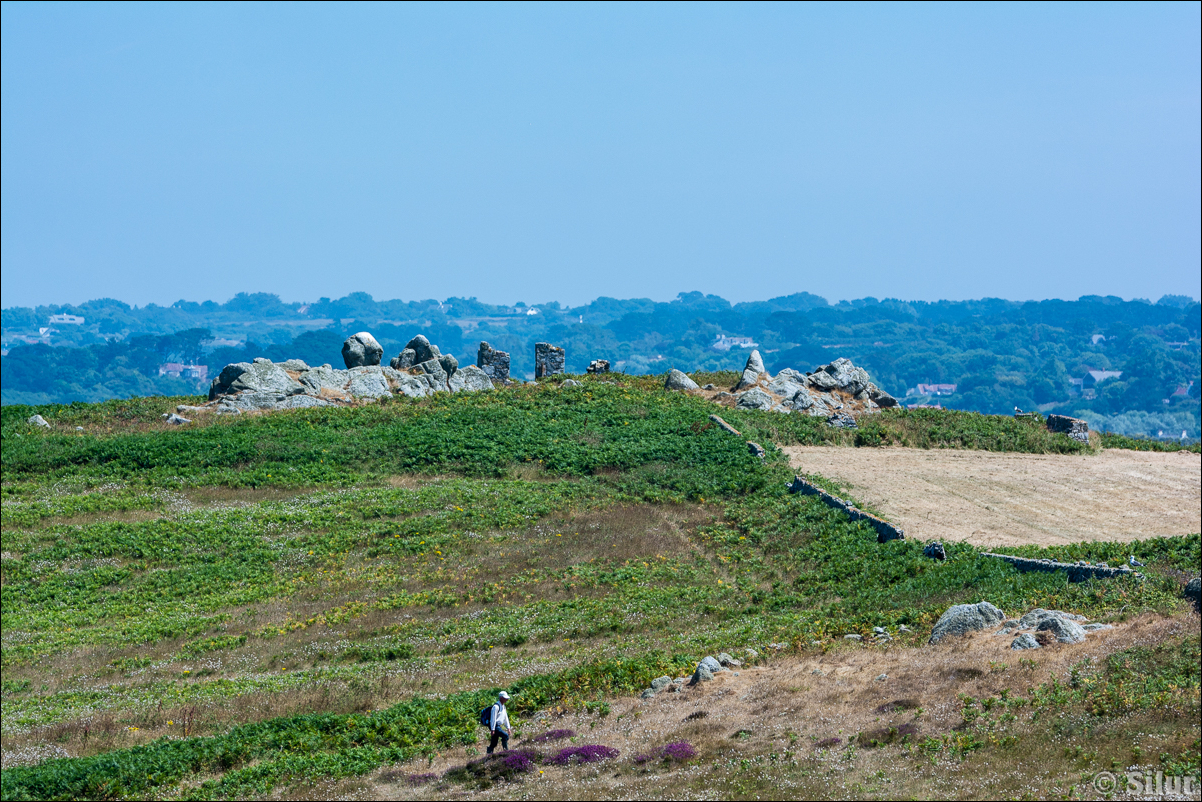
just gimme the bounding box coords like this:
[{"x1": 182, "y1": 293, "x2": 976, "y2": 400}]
[{"x1": 2, "y1": 292, "x2": 1202, "y2": 436}]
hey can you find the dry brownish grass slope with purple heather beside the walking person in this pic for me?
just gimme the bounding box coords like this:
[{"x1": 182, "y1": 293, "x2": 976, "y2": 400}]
[{"x1": 347, "y1": 614, "x2": 1200, "y2": 800}]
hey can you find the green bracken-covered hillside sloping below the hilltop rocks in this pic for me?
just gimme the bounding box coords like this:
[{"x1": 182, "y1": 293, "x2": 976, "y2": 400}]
[{"x1": 0, "y1": 378, "x2": 1202, "y2": 800}]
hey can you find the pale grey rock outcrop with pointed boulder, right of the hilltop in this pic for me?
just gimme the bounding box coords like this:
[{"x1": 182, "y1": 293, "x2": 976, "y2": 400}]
[{"x1": 664, "y1": 351, "x2": 898, "y2": 428}]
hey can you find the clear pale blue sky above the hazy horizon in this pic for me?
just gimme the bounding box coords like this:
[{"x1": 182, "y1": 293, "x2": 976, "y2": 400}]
[{"x1": 0, "y1": 2, "x2": 1202, "y2": 307}]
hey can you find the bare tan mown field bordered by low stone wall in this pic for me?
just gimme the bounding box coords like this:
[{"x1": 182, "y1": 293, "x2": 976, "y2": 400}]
[{"x1": 784, "y1": 446, "x2": 1202, "y2": 546}]
